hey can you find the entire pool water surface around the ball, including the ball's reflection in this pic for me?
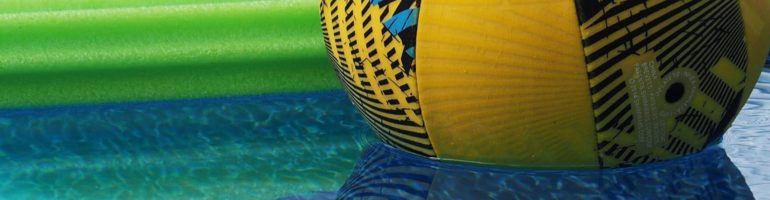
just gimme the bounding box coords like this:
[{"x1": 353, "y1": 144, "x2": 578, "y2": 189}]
[{"x1": 0, "y1": 65, "x2": 770, "y2": 199}]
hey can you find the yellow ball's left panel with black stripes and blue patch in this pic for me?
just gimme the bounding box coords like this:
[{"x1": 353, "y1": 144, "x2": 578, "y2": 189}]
[{"x1": 321, "y1": 0, "x2": 435, "y2": 156}]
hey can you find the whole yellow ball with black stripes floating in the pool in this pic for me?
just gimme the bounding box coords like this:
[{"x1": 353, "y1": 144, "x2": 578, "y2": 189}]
[{"x1": 320, "y1": 0, "x2": 770, "y2": 169}]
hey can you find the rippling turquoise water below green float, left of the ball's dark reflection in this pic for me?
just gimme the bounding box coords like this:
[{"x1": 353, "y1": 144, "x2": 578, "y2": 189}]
[{"x1": 0, "y1": 92, "x2": 373, "y2": 199}]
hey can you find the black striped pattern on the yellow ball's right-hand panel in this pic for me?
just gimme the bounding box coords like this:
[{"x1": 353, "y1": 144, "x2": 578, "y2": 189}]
[{"x1": 575, "y1": 0, "x2": 747, "y2": 167}]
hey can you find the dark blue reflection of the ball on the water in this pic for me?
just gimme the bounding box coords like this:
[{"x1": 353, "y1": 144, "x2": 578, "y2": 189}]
[{"x1": 338, "y1": 144, "x2": 753, "y2": 199}]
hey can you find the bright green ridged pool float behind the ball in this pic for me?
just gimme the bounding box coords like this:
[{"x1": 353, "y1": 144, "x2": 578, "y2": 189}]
[{"x1": 0, "y1": 0, "x2": 339, "y2": 109}]
